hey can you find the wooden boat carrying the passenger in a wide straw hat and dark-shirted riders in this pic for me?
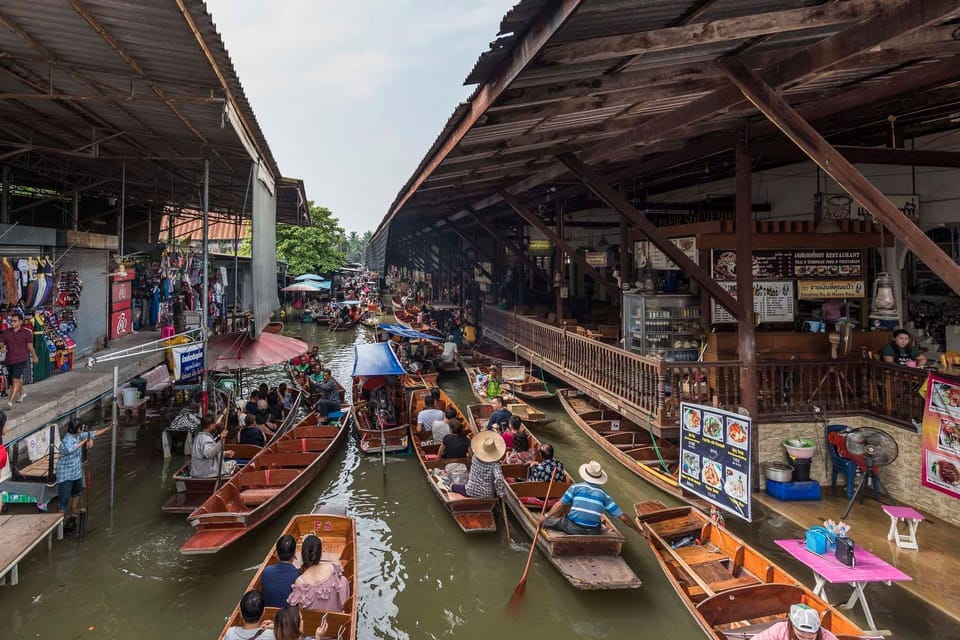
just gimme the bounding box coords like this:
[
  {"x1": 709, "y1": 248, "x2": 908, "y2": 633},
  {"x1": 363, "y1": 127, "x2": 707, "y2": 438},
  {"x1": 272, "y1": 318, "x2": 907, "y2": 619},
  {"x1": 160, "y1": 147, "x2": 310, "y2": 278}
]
[{"x1": 410, "y1": 389, "x2": 499, "y2": 533}]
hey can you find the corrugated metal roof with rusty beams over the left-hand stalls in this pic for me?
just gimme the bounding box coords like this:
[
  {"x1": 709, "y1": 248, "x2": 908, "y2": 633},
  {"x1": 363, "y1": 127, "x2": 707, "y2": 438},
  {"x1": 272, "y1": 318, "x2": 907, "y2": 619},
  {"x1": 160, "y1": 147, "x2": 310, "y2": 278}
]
[{"x1": 0, "y1": 0, "x2": 305, "y2": 222}]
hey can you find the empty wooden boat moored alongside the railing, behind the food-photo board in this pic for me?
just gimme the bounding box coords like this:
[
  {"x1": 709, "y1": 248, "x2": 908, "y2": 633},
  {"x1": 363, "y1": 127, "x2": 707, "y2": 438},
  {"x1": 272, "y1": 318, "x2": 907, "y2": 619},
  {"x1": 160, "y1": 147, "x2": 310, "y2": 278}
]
[{"x1": 557, "y1": 389, "x2": 710, "y2": 509}]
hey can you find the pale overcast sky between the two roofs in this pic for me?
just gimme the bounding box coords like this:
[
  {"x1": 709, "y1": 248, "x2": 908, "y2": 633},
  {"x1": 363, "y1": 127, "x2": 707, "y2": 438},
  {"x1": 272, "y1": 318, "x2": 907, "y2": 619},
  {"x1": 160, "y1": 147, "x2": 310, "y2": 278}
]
[{"x1": 207, "y1": 0, "x2": 515, "y2": 232}]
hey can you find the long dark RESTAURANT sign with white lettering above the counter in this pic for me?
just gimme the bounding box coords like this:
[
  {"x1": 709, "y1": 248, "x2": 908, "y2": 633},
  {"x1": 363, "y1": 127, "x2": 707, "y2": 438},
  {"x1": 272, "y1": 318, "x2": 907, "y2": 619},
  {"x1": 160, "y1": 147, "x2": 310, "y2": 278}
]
[{"x1": 711, "y1": 249, "x2": 863, "y2": 280}]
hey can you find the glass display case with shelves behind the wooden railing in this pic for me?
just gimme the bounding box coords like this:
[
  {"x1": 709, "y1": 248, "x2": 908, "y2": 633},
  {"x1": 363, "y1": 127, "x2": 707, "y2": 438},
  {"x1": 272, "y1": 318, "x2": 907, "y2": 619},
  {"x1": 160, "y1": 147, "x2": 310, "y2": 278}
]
[{"x1": 623, "y1": 293, "x2": 703, "y2": 362}]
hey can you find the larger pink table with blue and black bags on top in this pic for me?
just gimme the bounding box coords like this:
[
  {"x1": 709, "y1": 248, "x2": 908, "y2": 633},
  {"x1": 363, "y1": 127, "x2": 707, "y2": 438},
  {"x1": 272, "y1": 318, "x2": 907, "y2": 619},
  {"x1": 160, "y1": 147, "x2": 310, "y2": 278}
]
[{"x1": 774, "y1": 540, "x2": 913, "y2": 635}]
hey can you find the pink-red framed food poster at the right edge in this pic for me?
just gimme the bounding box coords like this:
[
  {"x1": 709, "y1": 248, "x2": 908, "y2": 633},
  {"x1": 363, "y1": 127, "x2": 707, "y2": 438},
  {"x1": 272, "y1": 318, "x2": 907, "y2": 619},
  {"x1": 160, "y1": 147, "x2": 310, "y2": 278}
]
[{"x1": 920, "y1": 374, "x2": 960, "y2": 498}]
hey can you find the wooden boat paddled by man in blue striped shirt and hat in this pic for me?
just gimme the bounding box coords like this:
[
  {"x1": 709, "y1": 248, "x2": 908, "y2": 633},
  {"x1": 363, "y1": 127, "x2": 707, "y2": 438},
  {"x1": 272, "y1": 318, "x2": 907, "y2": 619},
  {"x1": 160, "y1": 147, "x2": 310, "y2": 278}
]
[{"x1": 503, "y1": 465, "x2": 641, "y2": 590}]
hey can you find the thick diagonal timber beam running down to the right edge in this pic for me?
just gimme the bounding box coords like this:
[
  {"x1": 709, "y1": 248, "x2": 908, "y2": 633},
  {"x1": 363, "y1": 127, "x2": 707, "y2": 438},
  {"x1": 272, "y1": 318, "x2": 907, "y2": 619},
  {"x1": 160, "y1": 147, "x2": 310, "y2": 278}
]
[{"x1": 717, "y1": 58, "x2": 960, "y2": 293}]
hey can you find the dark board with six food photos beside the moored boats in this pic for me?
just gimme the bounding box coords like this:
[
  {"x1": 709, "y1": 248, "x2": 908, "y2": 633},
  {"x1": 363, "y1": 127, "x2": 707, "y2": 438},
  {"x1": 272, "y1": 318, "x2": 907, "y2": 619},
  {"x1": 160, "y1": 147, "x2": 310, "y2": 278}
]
[{"x1": 680, "y1": 402, "x2": 752, "y2": 522}]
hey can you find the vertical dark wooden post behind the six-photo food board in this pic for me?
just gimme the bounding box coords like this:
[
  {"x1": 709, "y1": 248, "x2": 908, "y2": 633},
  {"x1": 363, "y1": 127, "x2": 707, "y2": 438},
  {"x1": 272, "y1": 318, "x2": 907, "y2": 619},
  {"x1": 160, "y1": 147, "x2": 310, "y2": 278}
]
[{"x1": 735, "y1": 131, "x2": 760, "y2": 489}]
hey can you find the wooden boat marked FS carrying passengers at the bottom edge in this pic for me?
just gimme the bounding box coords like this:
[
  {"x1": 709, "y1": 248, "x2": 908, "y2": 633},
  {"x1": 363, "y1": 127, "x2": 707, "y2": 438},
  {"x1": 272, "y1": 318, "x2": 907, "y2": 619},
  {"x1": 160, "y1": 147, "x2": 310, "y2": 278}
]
[{"x1": 219, "y1": 514, "x2": 358, "y2": 640}]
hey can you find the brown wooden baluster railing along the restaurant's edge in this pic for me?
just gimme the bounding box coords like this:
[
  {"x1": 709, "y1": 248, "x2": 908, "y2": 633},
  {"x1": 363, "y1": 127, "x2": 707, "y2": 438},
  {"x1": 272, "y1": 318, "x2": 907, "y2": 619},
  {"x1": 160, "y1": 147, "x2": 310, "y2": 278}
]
[{"x1": 482, "y1": 307, "x2": 926, "y2": 429}]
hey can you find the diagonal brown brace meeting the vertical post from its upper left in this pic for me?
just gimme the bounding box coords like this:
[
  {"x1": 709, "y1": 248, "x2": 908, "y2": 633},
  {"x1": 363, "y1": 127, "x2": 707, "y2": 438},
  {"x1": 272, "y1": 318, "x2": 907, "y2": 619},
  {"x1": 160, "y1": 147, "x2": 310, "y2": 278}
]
[{"x1": 557, "y1": 153, "x2": 741, "y2": 319}]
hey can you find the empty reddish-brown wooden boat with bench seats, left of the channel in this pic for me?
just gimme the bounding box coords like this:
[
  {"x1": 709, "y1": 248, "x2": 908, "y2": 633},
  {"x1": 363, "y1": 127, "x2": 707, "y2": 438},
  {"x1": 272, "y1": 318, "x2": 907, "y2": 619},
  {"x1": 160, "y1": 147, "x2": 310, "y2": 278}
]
[{"x1": 180, "y1": 405, "x2": 351, "y2": 555}]
